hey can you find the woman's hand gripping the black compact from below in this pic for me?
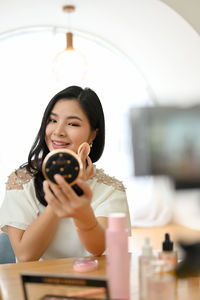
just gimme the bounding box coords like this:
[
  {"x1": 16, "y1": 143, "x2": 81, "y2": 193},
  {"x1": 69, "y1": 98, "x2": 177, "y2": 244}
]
[{"x1": 43, "y1": 174, "x2": 92, "y2": 219}]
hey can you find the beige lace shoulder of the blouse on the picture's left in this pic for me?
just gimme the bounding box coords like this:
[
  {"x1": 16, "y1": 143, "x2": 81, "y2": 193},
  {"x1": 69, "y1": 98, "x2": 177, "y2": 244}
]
[{"x1": 6, "y1": 168, "x2": 33, "y2": 190}]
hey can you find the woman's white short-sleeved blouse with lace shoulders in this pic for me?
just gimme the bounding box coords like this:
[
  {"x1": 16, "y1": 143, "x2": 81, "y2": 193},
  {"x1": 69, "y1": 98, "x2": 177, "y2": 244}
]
[{"x1": 0, "y1": 169, "x2": 131, "y2": 259}]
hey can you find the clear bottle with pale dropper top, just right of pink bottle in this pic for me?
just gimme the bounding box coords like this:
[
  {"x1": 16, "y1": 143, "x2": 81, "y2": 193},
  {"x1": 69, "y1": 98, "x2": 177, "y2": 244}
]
[{"x1": 139, "y1": 237, "x2": 155, "y2": 300}]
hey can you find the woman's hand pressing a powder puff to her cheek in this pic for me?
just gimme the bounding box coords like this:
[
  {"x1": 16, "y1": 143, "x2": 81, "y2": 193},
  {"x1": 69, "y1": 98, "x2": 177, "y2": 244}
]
[{"x1": 78, "y1": 142, "x2": 95, "y2": 180}]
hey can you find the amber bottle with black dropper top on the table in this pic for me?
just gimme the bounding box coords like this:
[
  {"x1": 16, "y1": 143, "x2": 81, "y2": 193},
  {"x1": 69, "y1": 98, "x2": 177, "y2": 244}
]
[{"x1": 158, "y1": 233, "x2": 178, "y2": 270}]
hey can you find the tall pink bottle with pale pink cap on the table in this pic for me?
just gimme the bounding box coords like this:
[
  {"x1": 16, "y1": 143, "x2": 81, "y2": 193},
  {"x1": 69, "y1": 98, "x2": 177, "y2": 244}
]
[{"x1": 106, "y1": 213, "x2": 130, "y2": 300}]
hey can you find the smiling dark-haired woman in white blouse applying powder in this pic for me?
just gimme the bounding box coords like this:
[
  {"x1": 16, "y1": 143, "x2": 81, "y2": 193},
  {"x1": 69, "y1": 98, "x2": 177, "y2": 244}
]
[{"x1": 0, "y1": 86, "x2": 130, "y2": 261}]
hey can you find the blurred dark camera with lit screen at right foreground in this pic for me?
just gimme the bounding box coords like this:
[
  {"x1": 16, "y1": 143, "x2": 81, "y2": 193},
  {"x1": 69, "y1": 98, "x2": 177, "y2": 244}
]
[{"x1": 130, "y1": 106, "x2": 200, "y2": 189}]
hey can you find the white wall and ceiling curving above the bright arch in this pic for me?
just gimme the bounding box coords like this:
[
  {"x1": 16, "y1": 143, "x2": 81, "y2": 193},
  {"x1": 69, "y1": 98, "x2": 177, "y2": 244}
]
[{"x1": 0, "y1": 0, "x2": 200, "y2": 104}]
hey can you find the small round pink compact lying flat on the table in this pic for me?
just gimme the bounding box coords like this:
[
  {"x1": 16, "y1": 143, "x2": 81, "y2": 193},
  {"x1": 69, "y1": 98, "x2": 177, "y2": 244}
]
[{"x1": 73, "y1": 257, "x2": 98, "y2": 272}]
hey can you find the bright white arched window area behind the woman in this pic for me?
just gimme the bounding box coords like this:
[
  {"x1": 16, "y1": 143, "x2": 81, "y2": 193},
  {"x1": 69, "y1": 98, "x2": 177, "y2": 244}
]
[{"x1": 0, "y1": 26, "x2": 153, "y2": 223}]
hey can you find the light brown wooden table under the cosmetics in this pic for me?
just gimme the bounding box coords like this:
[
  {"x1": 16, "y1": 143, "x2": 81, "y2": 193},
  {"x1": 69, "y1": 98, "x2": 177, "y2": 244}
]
[{"x1": 0, "y1": 224, "x2": 200, "y2": 300}]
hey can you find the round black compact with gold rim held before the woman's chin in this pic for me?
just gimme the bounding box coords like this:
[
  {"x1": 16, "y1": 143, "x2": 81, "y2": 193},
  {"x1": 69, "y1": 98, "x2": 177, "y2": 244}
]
[{"x1": 42, "y1": 149, "x2": 83, "y2": 196}]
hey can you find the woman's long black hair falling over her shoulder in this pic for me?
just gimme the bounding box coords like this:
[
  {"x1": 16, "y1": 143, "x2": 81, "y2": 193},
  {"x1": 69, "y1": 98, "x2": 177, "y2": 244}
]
[{"x1": 24, "y1": 86, "x2": 105, "y2": 206}]
